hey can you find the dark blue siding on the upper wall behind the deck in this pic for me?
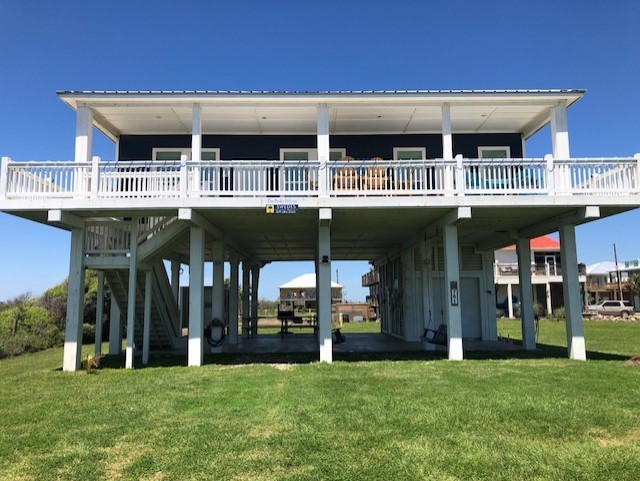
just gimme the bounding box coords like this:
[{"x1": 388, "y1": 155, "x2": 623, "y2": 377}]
[{"x1": 119, "y1": 134, "x2": 522, "y2": 160}]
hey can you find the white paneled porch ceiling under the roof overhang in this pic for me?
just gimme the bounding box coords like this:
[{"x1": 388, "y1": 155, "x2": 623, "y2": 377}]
[{"x1": 59, "y1": 90, "x2": 584, "y2": 138}]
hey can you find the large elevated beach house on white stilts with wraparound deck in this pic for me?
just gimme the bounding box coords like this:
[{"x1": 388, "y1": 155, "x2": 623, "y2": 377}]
[{"x1": 0, "y1": 90, "x2": 640, "y2": 371}]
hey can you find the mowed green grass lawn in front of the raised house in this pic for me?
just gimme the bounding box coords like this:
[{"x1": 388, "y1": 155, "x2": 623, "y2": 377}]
[{"x1": 0, "y1": 321, "x2": 640, "y2": 481}]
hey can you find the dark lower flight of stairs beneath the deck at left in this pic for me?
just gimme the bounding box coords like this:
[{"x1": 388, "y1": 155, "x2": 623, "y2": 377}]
[{"x1": 104, "y1": 260, "x2": 184, "y2": 350}]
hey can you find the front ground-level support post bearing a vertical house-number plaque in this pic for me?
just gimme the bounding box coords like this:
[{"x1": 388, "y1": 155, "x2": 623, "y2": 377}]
[{"x1": 443, "y1": 225, "x2": 463, "y2": 361}]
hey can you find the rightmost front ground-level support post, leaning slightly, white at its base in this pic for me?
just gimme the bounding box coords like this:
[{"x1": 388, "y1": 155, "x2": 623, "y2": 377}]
[{"x1": 559, "y1": 225, "x2": 587, "y2": 361}]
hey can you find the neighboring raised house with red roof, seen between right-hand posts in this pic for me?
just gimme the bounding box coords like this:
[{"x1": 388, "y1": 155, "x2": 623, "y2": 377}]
[{"x1": 494, "y1": 236, "x2": 587, "y2": 318}]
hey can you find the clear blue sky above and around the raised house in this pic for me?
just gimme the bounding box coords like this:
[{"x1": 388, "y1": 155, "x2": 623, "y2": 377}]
[{"x1": 0, "y1": 0, "x2": 640, "y2": 300}]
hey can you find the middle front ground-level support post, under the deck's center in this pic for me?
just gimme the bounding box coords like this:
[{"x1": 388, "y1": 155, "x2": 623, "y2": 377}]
[{"x1": 316, "y1": 208, "x2": 333, "y2": 363}]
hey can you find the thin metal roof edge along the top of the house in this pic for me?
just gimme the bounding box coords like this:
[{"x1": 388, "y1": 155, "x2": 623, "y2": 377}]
[{"x1": 56, "y1": 89, "x2": 586, "y2": 95}]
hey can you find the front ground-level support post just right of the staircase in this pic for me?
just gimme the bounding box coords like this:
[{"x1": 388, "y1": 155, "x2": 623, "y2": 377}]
[{"x1": 187, "y1": 226, "x2": 204, "y2": 366}]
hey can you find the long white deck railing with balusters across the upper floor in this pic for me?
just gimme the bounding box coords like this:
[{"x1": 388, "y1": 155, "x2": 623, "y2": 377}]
[{"x1": 0, "y1": 155, "x2": 640, "y2": 199}]
